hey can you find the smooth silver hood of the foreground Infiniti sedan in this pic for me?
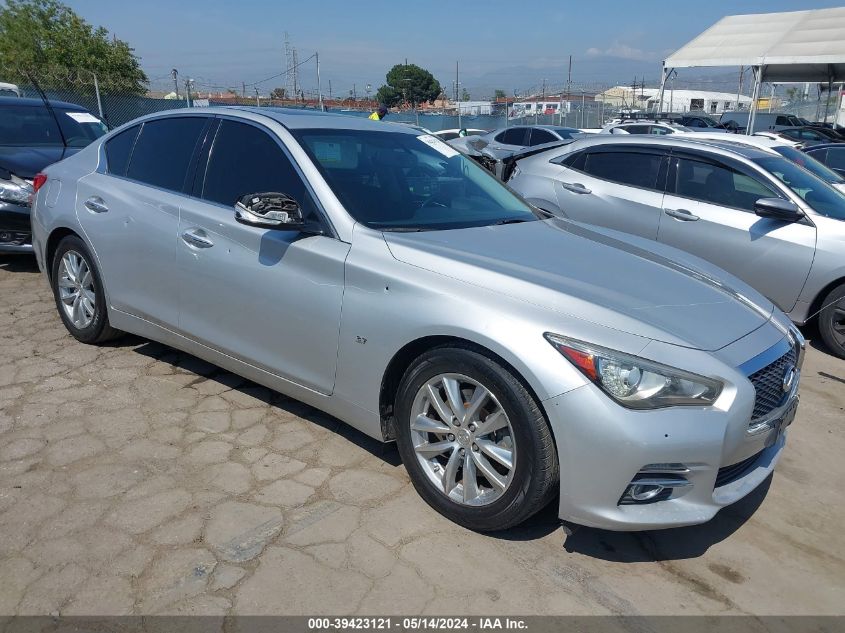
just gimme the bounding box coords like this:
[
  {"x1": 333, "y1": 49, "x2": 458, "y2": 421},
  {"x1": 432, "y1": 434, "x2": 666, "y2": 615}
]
[{"x1": 384, "y1": 220, "x2": 773, "y2": 350}]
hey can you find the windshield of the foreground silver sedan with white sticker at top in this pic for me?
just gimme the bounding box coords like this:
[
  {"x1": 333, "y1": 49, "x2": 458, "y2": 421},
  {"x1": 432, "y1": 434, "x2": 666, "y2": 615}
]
[{"x1": 291, "y1": 129, "x2": 537, "y2": 231}]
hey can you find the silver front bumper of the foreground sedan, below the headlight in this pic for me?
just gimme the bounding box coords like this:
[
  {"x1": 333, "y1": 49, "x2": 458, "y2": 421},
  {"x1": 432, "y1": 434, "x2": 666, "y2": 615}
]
[{"x1": 544, "y1": 334, "x2": 798, "y2": 531}]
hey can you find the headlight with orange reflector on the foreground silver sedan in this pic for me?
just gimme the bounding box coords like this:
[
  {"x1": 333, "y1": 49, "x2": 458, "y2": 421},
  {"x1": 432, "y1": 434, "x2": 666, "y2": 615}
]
[{"x1": 545, "y1": 332, "x2": 722, "y2": 409}]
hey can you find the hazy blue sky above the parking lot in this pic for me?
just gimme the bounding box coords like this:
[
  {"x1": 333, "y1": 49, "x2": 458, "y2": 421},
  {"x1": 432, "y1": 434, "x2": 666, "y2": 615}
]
[{"x1": 66, "y1": 0, "x2": 842, "y2": 96}]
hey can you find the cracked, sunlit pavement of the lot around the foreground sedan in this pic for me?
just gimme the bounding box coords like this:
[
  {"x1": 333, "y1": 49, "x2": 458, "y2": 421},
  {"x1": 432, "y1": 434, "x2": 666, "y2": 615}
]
[{"x1": 0, "y1": 257, "x2": 845, "y2": 615}]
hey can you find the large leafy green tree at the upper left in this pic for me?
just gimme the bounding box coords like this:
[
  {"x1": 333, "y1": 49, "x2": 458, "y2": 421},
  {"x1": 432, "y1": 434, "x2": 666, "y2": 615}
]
[{"x1": 0, "y1": 0, "x2": 147, "y2": 94}]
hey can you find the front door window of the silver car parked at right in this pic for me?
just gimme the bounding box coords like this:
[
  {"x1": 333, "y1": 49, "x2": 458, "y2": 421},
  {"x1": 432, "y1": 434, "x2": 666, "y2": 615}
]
[{"x1": 668, "y1": 158, "x2": 787, "y2": 212}]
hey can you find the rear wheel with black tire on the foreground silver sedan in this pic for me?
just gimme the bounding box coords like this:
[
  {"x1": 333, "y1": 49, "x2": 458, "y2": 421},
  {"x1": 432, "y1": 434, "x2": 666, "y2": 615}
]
[{"x1": 50, "y1": 235, "x2": 123, "y2": 344}]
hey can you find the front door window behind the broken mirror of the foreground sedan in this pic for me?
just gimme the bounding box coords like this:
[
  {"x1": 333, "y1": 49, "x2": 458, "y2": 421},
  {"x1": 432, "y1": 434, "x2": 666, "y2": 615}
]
[{"x1": 202, "y1": 121, "x2": 314, "y2": 215}]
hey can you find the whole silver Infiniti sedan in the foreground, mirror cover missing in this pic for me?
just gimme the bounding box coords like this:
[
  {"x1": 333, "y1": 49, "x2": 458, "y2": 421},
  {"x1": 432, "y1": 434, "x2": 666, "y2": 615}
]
[{"x1": 28, "y1": 108, "x2": 804, "y2": 530}]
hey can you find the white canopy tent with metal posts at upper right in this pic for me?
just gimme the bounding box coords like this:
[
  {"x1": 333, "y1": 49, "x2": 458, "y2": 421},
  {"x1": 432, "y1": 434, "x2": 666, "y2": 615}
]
[{"x1": 658, "y1": 7, "x2": 845, "y2": 134}]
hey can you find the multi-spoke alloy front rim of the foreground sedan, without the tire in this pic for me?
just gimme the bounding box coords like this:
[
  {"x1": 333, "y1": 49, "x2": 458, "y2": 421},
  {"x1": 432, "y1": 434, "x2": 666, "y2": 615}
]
[{"x1": 411, "y1": 374, "x2": 516, "y2": 506}]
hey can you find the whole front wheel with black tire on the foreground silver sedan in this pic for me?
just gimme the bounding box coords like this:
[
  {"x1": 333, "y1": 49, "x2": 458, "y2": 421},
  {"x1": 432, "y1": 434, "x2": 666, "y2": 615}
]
[{"x1": 395, "y1": 347, "x2": 558, "y2": 532}]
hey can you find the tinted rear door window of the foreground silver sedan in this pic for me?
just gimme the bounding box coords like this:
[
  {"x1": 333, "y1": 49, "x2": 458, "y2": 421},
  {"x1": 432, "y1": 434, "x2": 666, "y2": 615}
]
[{"x1": 126, "y1": 117, "x2": 207, "y2": 191}]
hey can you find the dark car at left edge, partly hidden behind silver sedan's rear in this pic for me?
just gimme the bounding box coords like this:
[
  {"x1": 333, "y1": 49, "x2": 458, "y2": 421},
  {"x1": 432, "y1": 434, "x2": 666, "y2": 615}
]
[{"x1": 0, "y1": 97, "x2": 106, "y2": 253}]
